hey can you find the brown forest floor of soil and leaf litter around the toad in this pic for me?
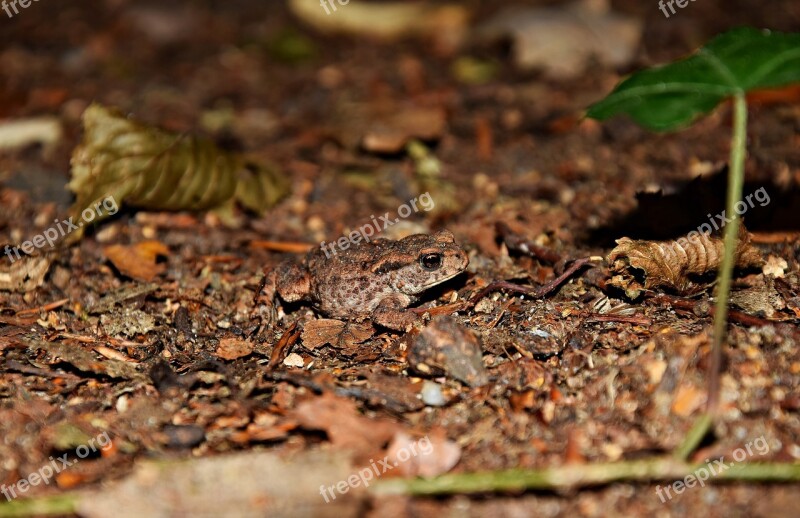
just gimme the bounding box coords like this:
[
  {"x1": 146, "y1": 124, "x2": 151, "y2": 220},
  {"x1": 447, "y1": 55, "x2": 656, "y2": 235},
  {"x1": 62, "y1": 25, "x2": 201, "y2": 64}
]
[{"x1": 0, "y1": 0, "x2": 800, "y2": 517}]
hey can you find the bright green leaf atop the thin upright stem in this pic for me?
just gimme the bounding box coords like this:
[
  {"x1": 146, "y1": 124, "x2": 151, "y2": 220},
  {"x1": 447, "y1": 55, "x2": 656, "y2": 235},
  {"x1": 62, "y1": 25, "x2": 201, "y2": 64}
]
[{"x1": 587, "y1": 27, "x2": 800, "y2": 131}]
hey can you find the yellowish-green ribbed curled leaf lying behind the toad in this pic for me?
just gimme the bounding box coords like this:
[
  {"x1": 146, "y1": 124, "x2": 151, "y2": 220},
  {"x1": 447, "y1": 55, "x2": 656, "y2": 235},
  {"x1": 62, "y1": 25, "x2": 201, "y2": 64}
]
[{"x1": 69, "y1": 104, "x2": 288, "y2": 230}]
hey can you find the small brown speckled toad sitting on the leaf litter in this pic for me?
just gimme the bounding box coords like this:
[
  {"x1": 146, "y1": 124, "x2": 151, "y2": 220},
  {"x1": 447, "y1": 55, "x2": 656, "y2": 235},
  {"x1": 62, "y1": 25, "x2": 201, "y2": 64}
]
[{"x1": 276, "y1": 230, "x2": 469, "y2": 331}]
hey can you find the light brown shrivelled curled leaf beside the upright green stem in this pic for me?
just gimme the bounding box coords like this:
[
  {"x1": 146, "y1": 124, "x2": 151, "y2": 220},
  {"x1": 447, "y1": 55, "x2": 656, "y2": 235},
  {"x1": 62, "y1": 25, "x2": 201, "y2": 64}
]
[{"x1": 608, "y1": 230, "x2": 764, "y2": 298}]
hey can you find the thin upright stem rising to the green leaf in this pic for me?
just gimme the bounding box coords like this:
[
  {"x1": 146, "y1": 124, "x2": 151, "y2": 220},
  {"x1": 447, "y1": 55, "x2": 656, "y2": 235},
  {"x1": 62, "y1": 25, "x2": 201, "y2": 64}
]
[{"x1": 706, "y1": 92, "x2": 747, "y2": 416}]
